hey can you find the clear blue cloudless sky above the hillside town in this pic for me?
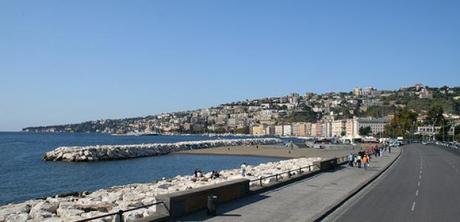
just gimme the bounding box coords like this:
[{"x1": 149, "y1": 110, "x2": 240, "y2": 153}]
[{"x1": 0, "y1": 0, "x2": 460, "y2": 131}]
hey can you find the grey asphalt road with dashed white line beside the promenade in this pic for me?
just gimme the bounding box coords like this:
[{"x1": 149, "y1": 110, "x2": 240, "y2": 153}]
[{"x1": 328, "y1": 144, "x2": 460, "y2": 222}]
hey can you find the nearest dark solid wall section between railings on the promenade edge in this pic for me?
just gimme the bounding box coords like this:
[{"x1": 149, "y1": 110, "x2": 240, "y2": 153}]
[{"x1": 159, "y1": 179, "x2": 249, "y2": 218}]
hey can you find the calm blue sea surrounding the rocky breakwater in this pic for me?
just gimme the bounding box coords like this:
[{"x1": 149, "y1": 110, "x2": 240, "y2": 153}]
[{"x1": 0, "y1": 132, "x2": 278, "y2": 205}]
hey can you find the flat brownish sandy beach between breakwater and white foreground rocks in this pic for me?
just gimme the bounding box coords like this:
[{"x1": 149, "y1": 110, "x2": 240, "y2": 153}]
[{"x1": 174, "y1": 145, "x2": 360, "y2": 159}]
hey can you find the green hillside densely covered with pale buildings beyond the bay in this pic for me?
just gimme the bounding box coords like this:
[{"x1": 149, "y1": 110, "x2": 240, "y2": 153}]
[{"x1": 23, "y1": 84, "x2": 460, "y2": 137}]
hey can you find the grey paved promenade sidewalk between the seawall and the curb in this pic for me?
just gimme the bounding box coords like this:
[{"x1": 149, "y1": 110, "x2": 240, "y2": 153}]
[{"x1": 178, "y1": 148, "x2": 400, "y2": 222}]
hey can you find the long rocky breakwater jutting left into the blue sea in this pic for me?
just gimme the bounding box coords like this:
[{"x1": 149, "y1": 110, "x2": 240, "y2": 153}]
[{"x1": 43, "y1": 138, "x2": 282, "y2": 162}]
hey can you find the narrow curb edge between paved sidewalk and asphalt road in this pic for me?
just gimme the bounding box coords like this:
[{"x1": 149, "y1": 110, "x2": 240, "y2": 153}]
[{"x1": 311, "y1": 149, "x2": 402, "y2": 222}]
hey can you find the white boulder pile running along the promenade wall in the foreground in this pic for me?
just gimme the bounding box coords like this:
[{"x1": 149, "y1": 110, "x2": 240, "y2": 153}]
[{"x1": 0, "y1": 158, "x2": 321, "y2": 222}]
